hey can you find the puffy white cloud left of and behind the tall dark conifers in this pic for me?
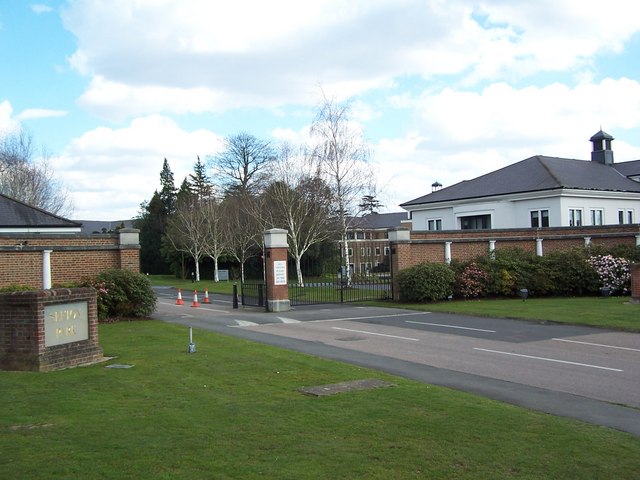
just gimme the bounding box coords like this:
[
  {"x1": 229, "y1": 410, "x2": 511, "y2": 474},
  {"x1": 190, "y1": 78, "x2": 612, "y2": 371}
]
[{"x1": 52, "y1": 115, "x2": 226, "y2": 220}]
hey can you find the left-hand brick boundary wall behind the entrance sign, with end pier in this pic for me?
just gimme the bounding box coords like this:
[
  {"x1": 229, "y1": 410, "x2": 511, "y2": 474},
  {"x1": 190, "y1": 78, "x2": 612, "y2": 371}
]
[{"x1": 0, "y1": 229, "x2": 140, "y2": 288}]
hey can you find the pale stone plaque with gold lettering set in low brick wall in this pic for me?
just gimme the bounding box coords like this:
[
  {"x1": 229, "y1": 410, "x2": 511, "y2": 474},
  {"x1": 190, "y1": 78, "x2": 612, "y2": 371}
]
[{"x1": 44, "y1": 302, "x2": 89, "y2": 347}]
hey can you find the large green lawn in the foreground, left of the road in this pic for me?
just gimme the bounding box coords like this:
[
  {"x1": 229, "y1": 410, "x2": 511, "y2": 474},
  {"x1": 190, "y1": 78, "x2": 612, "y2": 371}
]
[{"x1": 0, "y1": 321, "x2": 640, "y2": 480}]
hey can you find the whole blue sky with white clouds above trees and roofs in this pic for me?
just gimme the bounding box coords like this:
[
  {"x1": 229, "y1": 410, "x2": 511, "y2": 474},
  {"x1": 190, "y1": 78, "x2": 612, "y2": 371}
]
[{"x1": 0, "y1": 0, "x2": 640, "y2": 221}]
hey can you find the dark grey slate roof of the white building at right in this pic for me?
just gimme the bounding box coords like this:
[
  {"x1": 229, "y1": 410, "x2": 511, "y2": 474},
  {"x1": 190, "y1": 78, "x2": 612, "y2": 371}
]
[{"x1": 400, "y1": 155, "x2": 640, "y2": 207}]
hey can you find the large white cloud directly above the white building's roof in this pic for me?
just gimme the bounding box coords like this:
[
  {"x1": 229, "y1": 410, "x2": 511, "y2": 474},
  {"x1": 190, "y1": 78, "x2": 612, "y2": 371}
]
[{"x1": 376, "y1": 78, "x2": 640, "y2": 208}]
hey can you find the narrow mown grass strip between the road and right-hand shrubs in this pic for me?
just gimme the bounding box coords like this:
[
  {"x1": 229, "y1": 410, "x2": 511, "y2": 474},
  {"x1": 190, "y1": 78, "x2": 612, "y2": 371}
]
[{"x1": 379, "y1": 297, "x2": 640, "y2": 332}]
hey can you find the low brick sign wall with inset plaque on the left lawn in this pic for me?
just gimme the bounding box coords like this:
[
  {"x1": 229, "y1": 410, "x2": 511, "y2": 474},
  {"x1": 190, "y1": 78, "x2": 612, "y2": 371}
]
[{"x1": 0, "y1": 288, "x2": 103, "y2": 371}]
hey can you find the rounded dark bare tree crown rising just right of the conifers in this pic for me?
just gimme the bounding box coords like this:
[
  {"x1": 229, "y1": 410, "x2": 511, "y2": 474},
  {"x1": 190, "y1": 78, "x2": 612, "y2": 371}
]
[{"x1": 209, "y1": 133, "x2": 274, "y2": 194}]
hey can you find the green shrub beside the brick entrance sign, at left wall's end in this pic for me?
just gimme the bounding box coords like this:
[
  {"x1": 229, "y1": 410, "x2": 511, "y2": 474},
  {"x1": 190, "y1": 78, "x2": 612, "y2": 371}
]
[{"x1": 84, "y1": 269, "x2": 156, "y2": 321}]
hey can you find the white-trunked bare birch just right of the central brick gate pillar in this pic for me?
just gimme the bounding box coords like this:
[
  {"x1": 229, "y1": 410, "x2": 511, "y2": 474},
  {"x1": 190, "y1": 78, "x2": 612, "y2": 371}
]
[{"x1": 264, "y1": 145, "x2": 335, "y2": 287}]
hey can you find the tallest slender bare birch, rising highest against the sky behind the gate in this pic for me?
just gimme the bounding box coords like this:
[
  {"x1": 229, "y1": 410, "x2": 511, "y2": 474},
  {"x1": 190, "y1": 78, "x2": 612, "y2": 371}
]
[{"x1": 311, "y1": 96, "x2": 374, "y2": 284}]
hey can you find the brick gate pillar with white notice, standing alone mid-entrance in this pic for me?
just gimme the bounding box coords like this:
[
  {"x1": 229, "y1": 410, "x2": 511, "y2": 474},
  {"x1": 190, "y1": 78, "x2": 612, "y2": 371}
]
[{"x1": 263, "y1": 228, "x2": 291, "y2": 312}]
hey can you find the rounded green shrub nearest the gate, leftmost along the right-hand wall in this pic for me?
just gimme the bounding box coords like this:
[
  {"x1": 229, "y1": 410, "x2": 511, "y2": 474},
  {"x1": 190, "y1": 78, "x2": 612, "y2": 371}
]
[{"x1": 398, "y1": 263, "x2": 456, "y2": 302}]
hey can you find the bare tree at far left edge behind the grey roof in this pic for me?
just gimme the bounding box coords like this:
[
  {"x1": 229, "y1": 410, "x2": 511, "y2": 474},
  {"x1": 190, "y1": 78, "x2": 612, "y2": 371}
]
[{"x1": 0, "y1": 132, "x2": 73, "y2": 215}]
